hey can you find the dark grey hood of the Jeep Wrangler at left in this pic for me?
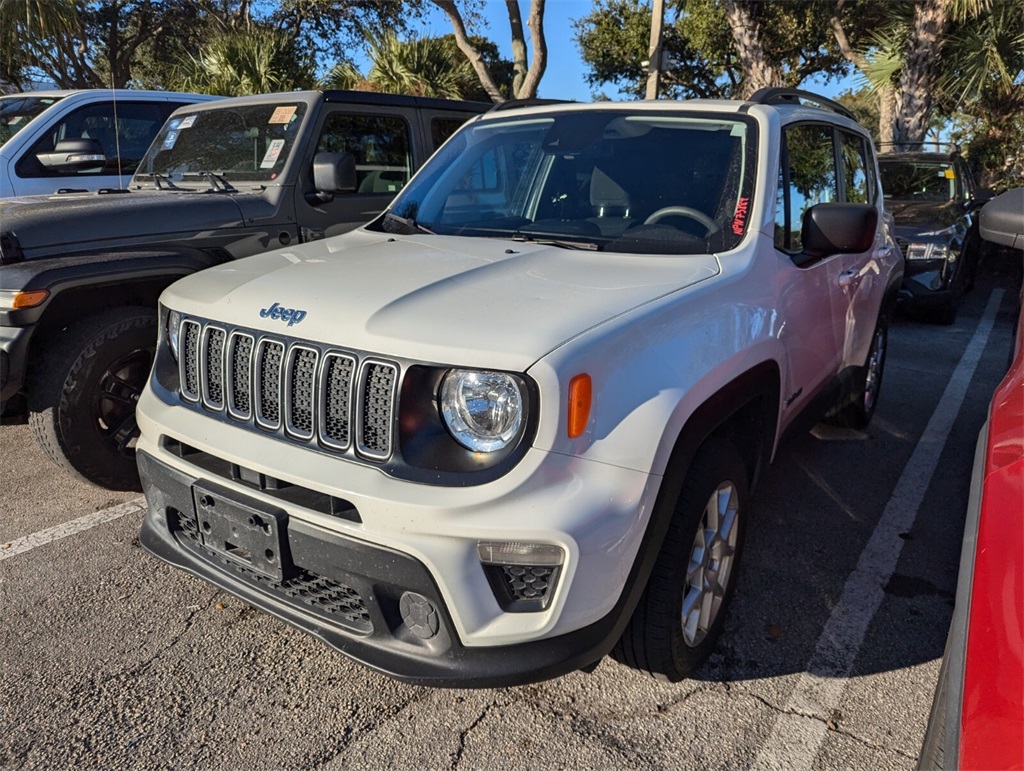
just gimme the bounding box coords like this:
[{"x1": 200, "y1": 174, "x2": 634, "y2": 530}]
[{"x1": 0, "y1": 190, "x2": 243, "y2": 259}]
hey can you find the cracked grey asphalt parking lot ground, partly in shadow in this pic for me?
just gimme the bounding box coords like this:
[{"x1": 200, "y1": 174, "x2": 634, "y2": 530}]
[{"x1": 0, "y1": 258, "x2": 1019, "y2": 769}]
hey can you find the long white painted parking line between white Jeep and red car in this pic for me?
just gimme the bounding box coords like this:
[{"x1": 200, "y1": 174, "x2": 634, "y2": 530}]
[{"x1": 752, "y1": 290, "x2": 1002, "y2": 771}]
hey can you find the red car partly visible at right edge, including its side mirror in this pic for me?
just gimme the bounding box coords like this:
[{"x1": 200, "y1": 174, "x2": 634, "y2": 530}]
[{"x1": 919, "y1": 188, "x2": 1024, "y2": 771}]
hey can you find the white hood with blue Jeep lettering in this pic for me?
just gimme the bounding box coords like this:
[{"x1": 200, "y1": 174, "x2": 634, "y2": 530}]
[{"x1": 162, "y1": 230, "x2": 720, "y2": 372}]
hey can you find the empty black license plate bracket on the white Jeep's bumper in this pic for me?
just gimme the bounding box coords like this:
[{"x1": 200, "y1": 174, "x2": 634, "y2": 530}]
[{"x1": 193, "y1": 482, "x2": 291, "y2": 582}]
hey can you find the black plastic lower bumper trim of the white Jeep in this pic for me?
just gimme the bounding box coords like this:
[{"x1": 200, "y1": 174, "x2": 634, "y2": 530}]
[{"x1": 136, "y1": 452, "x2": 626, "y2": 688}]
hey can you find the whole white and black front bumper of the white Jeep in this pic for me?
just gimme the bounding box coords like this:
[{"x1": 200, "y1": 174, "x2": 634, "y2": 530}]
[{"x1": 137, "y1": 389, "x2": 660, "y2": 687}]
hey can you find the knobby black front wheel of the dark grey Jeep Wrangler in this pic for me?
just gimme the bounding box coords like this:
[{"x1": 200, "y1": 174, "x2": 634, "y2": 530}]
[{"x1": 29, "y1": 308, "x2": 157, "y2": 490}]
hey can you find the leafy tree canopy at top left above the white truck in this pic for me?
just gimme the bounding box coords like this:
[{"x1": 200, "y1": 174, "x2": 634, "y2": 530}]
[{"x1": 0, "y1": 0, "x2": 423, "y2": 88}]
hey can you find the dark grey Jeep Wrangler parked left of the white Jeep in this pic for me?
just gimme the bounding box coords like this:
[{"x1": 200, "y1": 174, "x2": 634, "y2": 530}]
[{"x1": 0, "y1": 91, "x2": 490, "y2": 489}]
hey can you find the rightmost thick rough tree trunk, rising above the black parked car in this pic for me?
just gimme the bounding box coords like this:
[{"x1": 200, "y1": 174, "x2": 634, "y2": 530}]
[{"x1": 893, "y1": 0, "x2": 951, "y2": 149}]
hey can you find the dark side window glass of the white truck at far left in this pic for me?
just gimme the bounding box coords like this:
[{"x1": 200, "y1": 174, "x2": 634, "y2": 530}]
[{"x1": 15, "y1": 101, "x2": 187, "y2": 179}]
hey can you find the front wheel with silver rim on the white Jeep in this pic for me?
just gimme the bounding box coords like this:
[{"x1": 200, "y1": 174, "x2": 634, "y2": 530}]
[{"x1": 611, "y1": 439, "x2": 749, "y2": 683}]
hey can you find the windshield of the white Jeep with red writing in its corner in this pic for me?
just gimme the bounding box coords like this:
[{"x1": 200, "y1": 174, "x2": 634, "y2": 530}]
[{"x1": 372, "y1": 110, "x2": 757, "y2": 254}]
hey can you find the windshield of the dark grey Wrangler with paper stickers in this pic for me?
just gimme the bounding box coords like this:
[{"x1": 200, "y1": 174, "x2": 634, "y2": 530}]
[{"x1": 132, "y1": 103, "x2": 306, "y2": 190}]
